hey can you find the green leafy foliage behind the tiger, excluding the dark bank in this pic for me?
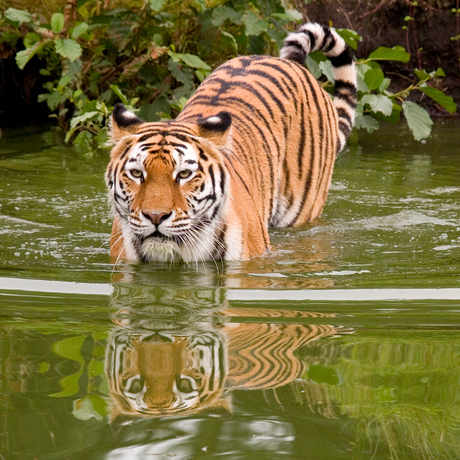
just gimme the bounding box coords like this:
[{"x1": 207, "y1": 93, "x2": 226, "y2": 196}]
[{"x1": 0, "y1": 0, "x2": 456, "y2": 151}]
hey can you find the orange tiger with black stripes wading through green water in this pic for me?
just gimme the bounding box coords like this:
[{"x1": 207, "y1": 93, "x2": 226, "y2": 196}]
[{"x1": 105, "y1": 23, "x2": 357, "y2": 263}]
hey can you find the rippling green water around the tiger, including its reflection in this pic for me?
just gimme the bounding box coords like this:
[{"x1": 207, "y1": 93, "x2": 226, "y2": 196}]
[{"x1": 0, "y1": 121, "x2": 460, "y2": 460}]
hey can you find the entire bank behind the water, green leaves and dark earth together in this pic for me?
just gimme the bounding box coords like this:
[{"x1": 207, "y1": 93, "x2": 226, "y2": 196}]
[{"x1": 0, "y1": 0, "x2": 460, "y2": 153}]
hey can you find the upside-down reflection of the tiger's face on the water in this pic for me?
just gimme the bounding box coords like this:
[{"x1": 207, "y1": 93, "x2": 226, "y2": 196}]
[{"x1": 105, "y1": 329, "x2": 229, "y2": 420}]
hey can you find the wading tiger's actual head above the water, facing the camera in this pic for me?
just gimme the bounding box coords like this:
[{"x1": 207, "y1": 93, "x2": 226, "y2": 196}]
[{"x1": 106, "y1": 104, "x2": 231, "y2": 262}]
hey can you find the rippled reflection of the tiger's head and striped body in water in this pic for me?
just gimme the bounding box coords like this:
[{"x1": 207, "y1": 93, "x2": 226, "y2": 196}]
[{"x1": 106, "y1": 289, "x2": 346, "y2": 420}]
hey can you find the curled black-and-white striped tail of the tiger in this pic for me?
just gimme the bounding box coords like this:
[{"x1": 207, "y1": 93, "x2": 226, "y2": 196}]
[{"x1": 280, "y1": 23, "x2": 358, "y2": 153}]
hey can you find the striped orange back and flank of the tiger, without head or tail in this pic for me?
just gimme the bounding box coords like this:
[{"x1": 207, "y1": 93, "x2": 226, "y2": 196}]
[{"x1": 178, "y1": 56, "x2": 338, "y2": 228}]
